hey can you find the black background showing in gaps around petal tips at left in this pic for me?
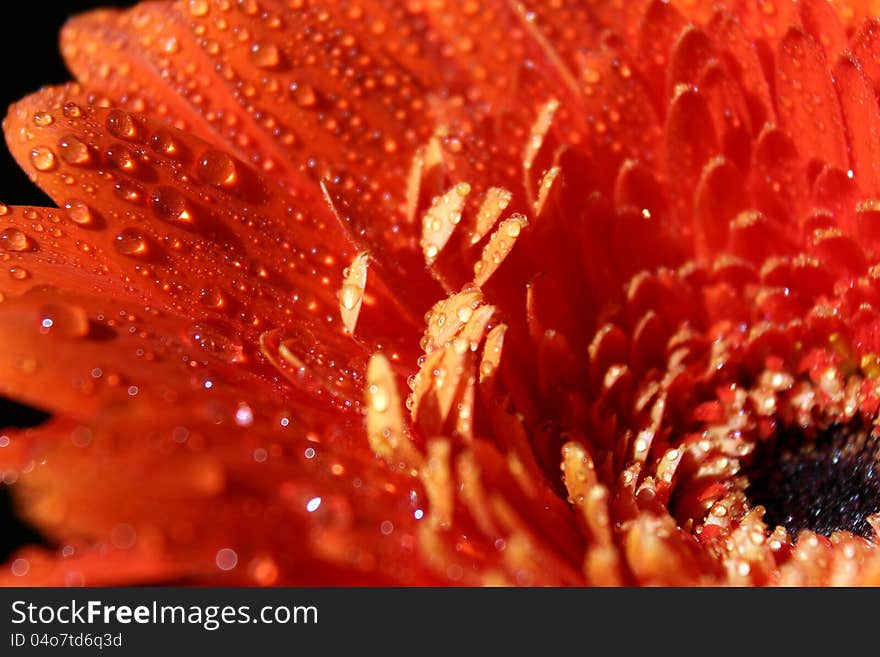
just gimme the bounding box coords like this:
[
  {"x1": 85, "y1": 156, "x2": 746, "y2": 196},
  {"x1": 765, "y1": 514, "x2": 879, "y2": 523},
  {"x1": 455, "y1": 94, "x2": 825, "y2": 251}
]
[{"x1": 0, "y1": 0, "x2": 134, "y2": 563}]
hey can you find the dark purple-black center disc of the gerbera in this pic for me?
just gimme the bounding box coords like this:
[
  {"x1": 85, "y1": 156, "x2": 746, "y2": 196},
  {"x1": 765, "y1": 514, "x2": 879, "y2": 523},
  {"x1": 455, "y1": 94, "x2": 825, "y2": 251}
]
[{"x1": 744, "y1": 422, "x2": 880, "y2": 538}]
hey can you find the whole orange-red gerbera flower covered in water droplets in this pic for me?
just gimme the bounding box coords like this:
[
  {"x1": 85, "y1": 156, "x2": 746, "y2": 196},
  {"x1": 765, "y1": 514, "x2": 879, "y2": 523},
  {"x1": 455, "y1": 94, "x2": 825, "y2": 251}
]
[{"x1": 0, "y1": 0, "x2": 880, "y2": 585}]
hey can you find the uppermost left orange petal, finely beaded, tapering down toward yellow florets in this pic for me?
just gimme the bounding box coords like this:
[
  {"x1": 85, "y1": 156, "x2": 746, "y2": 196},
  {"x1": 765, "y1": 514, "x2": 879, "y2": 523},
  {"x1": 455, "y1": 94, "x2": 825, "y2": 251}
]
[{"x1": 65, "y1": 2, "x2": 453, "y2": 318}]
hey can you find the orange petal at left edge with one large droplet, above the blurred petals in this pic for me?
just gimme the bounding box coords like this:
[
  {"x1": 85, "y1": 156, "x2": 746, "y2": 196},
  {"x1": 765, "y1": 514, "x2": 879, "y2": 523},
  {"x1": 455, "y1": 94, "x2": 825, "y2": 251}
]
[{"x1": 0, "y1": 286, "x2": 277, "y2": 419}]
